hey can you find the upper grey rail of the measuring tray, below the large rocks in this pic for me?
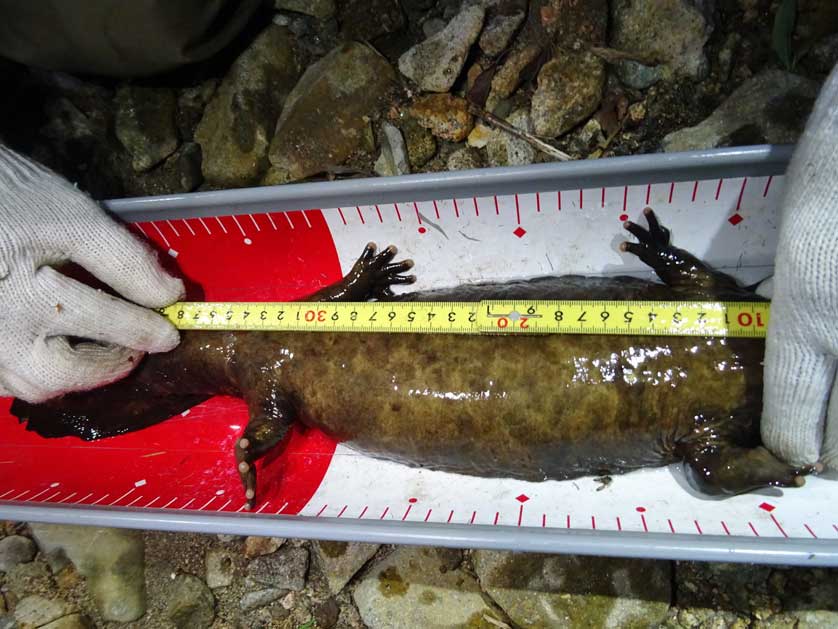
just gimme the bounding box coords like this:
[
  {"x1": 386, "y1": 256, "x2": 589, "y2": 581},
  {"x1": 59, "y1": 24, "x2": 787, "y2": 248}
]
[{"x1": 105, "y1": 145, "x2": 793, "y2": 221}]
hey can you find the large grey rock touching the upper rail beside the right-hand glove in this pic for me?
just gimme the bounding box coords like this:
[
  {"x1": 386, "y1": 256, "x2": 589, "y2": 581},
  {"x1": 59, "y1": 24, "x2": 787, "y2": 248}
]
[{"x1": 663, "y1": 70, "x2": 818, "y2": 151}]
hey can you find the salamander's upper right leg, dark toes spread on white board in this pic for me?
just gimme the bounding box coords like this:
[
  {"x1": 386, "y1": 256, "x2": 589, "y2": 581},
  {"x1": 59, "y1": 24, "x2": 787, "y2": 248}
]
[{"x1": 620, "y1": 207, "x2": 750, "y2": 298}]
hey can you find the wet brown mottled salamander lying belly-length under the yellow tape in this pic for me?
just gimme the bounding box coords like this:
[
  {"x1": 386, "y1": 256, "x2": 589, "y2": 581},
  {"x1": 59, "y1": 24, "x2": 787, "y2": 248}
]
[{"x1": 13, "y1": 210, "x2": 814, "y2": 504}]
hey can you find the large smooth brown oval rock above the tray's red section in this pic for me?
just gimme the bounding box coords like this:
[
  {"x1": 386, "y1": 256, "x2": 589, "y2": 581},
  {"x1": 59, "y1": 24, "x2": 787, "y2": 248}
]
[{"x1": 269, "y1": 42, "x2": 396, "y2": 180}]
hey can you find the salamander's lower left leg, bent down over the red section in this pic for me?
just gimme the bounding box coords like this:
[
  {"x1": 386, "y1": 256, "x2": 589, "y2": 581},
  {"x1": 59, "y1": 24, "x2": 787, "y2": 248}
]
[{"x1": 235, "y1": 396, "x2": 293, "y2": 509}]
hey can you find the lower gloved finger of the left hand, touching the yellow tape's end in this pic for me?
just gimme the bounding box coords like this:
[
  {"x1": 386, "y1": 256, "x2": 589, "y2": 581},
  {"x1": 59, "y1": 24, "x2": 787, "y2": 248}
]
[{"x1": 36, "y1": 267, "x2": 180, "y2": 353}]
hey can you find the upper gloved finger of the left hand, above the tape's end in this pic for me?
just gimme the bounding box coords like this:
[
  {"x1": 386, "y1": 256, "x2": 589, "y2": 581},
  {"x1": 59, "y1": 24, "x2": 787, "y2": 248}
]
[{"x1": 66, "y1": 207, "x2": 185, "y2": 308}]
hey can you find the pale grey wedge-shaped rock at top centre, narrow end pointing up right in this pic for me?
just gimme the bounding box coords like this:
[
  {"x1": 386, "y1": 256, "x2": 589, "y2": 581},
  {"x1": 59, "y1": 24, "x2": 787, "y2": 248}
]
[{"x1": 399, "y1": 6, "x2": 485, "y2": 92}]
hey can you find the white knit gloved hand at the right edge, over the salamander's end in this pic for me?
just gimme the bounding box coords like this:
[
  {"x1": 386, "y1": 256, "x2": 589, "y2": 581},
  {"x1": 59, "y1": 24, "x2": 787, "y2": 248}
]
[{"x1": 762, "y1": 67, "x2": 838, "y2": 470}]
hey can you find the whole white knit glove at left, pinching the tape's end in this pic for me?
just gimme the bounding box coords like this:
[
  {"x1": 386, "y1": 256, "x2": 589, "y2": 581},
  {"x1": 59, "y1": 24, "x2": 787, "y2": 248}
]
[{"x1": 0, "y1": 146, "x2": 184, "y2": 402}]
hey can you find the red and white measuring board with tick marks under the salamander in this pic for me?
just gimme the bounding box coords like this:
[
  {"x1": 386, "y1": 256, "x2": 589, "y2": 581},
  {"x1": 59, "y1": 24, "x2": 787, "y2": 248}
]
[{"x1": 0, "y1": 147, "x2": 838, "y2": 565}]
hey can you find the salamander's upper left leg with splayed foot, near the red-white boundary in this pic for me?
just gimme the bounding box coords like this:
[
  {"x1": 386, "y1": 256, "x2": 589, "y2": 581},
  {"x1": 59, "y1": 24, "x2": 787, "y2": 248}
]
[{"x1": 302, "y1": 242, "x2": 416, "y2": 301}]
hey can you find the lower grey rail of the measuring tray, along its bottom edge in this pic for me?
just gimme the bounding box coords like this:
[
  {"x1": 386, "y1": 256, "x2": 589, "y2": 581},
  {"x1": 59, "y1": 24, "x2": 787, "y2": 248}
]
[{"x1": 0, "y1": 502, "x2": 838, "y2": 567}]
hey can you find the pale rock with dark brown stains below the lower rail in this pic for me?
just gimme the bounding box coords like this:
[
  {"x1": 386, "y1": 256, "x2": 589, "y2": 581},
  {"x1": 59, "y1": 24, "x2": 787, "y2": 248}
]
[{"x1": 353, "y1": 546, "x2": 502, "y2": 629}]
